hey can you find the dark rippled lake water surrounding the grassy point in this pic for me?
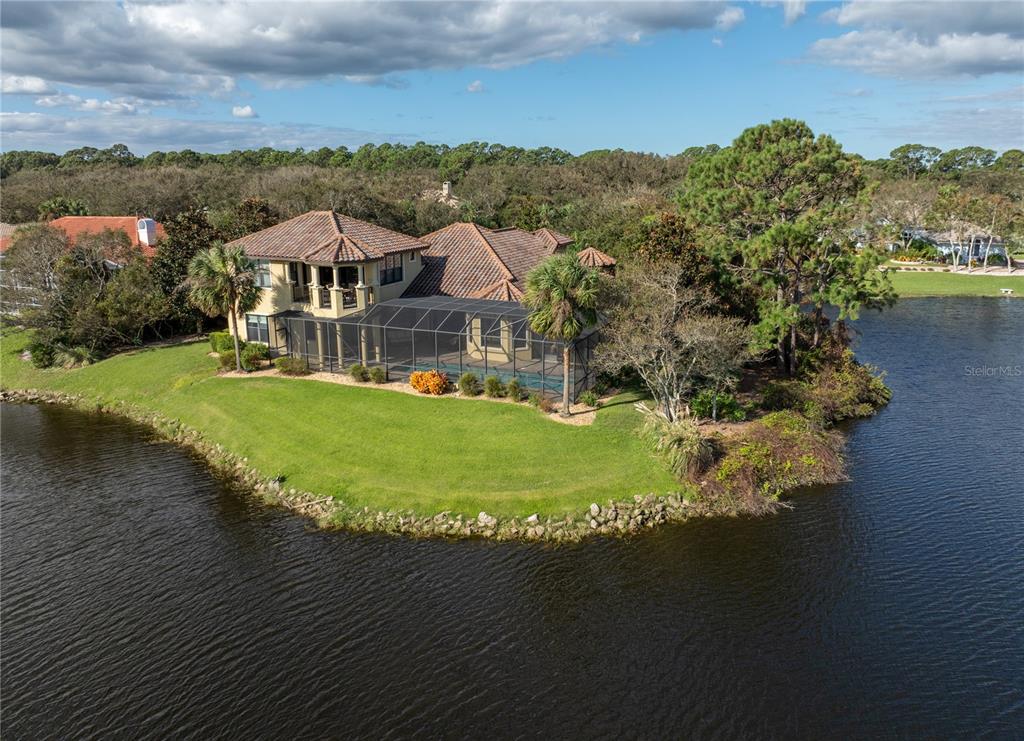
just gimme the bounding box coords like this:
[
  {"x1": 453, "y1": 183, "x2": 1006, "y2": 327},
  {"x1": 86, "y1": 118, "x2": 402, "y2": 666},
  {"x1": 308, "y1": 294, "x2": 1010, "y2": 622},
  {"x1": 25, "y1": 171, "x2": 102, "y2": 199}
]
[{"x1": 6, "y1": 299, "x2": 1024, "y2": 740}]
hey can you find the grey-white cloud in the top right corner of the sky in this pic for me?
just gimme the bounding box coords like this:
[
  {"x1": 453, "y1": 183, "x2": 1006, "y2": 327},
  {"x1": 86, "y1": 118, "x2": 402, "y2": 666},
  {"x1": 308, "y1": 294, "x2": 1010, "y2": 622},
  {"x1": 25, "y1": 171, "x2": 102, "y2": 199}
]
[{"x1": 809, "y1": 0, "x2": 1024, "y2": 79}]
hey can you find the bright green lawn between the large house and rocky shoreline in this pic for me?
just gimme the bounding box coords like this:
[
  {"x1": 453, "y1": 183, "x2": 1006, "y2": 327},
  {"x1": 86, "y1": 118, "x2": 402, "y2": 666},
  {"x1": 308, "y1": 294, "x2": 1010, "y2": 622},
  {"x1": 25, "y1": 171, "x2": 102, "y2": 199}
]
[{"x1": 0, "y1": 330, "x2": 679, "y2": 517}]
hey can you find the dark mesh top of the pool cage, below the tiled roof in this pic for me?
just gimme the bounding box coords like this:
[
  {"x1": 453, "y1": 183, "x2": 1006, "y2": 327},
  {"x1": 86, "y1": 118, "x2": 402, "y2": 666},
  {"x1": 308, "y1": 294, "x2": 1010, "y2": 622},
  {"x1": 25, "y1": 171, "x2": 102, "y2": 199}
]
[{"x1": 327, "y1": 296, "x2": 596, "y2": 339}]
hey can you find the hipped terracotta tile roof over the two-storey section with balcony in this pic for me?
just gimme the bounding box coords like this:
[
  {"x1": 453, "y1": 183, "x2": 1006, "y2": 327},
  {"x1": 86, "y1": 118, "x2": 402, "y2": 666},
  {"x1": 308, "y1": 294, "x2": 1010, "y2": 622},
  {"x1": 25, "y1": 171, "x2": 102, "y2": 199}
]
[{"x1": 229, "y1": 211, "x2": 427, "y2": 262}]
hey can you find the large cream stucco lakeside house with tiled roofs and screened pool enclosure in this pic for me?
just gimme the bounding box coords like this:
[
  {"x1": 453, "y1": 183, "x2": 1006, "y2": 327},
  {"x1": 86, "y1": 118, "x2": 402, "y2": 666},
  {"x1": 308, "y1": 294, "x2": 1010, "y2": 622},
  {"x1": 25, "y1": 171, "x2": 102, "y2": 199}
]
[{"x1": 230, "y1": 211, "x2": 614, "y2": 397}]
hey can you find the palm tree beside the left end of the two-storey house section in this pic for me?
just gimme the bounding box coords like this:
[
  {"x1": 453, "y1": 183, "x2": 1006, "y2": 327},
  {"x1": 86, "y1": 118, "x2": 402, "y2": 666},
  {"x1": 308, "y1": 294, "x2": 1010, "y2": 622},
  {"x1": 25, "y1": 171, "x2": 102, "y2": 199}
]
[{"x1": 186, "y1": 242, "x2": 261, "y2": 372}]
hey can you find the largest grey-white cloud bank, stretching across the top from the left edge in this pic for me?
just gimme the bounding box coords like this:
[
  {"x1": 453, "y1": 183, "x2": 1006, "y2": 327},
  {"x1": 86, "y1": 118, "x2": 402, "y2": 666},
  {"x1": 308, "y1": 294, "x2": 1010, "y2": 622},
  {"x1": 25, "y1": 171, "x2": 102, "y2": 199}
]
[{"x1": 2, "y1": 0, "x2": 743, "y2": 98}]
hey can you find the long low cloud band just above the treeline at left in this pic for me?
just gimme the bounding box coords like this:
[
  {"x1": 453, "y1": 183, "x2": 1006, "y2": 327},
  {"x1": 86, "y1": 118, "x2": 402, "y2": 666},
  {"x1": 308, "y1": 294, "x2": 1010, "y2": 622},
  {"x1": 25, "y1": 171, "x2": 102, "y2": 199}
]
[{"x1": 0, "y1": 112, "x2": 422, "y2": 155}]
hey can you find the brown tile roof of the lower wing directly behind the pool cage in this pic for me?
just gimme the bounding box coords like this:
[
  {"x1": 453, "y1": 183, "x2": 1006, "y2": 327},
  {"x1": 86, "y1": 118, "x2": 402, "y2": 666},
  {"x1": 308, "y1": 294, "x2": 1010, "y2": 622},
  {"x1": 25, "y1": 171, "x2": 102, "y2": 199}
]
[{"x1": 403, "y1": 222, "x2": 571, "y2": 301}]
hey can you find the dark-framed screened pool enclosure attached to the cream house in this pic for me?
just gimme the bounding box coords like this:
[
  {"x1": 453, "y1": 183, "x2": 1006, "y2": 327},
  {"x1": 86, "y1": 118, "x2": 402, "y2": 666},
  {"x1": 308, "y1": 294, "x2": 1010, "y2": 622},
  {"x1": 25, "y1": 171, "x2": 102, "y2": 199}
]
[{"x1": 269, "y1": 296, "x2": 598, "y2": 399}]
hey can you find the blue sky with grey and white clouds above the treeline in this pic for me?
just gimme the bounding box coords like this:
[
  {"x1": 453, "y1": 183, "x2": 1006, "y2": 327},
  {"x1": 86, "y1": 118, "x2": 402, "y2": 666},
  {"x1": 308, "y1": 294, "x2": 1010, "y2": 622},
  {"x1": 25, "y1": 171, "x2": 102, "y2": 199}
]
[{"x1": 0, "y1": 0, "x2": 1024, "y2": 158}]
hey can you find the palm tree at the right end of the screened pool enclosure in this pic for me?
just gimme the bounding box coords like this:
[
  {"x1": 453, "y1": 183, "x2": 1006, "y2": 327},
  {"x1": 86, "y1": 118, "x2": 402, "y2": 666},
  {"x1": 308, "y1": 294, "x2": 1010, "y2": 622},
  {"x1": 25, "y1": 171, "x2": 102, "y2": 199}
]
[{"x1": 522, "y1": 253, "x2": 600, "y2": 417}]
